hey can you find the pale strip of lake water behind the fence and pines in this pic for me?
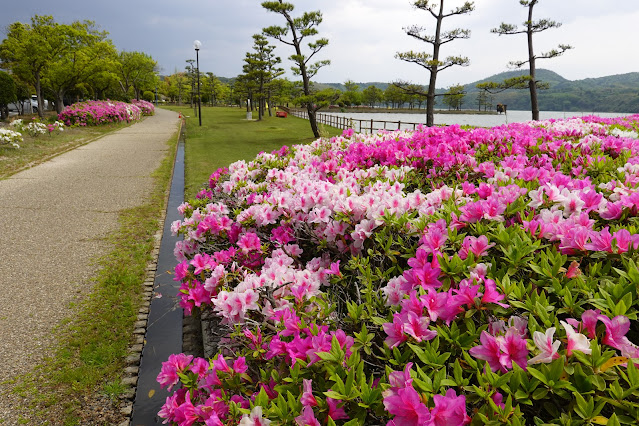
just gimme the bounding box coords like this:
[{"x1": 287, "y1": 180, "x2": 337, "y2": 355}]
[{"x1": 327, "y1": 111, "x2": 631, "y2": 131}]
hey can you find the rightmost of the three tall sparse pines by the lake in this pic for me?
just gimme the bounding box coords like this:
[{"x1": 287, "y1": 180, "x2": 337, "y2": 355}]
[{"x1": 491, "y1": 0, "x2": 572, "y2": 120}]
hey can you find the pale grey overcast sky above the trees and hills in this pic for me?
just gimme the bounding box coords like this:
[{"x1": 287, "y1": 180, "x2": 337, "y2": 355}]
[{"x1": 0, "y1": 0, "x2": 639, "y2": 87}]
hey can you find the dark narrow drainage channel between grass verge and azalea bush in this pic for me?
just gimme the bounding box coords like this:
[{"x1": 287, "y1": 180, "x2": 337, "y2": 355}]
[{"x1": 130, "y1": 124, "x2": 185, "y2": 426}]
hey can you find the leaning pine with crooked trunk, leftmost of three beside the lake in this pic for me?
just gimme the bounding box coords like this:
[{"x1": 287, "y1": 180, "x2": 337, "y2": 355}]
[{"x1": 262, "y1": 0, "x2": 331, "y2": 138}]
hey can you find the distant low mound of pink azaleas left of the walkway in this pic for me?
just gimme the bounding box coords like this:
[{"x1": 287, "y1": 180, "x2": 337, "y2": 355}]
[{"x1": 58, "y1": 101, "x2": 142, "y2": 126}]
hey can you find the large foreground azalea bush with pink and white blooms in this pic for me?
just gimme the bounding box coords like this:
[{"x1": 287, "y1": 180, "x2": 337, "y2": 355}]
[{"x1": 158, "y1": 115, "x2": 639, "y2": 426}]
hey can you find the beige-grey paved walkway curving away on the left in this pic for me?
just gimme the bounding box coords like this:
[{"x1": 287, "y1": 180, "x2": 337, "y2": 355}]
[{"x1": 0, "y1": 110, "x2": 178, "y2": 425}]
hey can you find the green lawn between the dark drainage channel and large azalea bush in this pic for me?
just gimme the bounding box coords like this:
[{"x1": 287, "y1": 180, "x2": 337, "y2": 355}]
[{"x1": 160, "y1": 106, "x2": 342, "y2": 199}]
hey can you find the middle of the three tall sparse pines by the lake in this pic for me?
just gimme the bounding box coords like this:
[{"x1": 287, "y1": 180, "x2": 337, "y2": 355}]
[{"x1": 395, "y1": 0, "x2": 475, "y2": 126}]
